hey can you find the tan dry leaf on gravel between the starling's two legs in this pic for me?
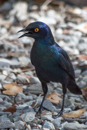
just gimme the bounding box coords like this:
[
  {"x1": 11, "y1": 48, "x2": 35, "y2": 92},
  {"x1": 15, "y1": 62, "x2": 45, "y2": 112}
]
[{"x1": 46, "y1": 92, "x2": 62, "y2": 104}]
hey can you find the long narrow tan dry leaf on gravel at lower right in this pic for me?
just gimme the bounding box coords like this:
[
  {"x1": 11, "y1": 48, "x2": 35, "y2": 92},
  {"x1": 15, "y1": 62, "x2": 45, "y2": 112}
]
[{"x1": 62, "y1": 109, "x2": 86, "y2": 118}]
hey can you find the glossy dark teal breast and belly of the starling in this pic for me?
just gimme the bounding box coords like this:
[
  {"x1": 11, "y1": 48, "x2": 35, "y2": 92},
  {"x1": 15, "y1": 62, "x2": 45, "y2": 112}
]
[{"x1": 31, "y1": 43, "x2": 68, "y2": 82}]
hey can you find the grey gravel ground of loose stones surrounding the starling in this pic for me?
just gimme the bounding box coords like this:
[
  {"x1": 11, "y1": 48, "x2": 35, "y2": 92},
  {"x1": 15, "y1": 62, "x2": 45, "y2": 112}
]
[{"x1": 0, "y1": 0, "x2": 87, "y2": 130}]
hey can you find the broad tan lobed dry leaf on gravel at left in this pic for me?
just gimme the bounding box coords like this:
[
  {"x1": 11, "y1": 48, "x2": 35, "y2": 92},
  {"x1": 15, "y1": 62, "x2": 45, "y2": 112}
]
[{"x1": 3, "y1": 83, "x2": 23, "y2": 95}]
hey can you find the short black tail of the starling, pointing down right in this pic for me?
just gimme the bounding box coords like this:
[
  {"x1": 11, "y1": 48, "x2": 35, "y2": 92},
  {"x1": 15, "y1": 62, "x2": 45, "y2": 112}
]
[{"x1": 67, "y1": 80, "x2": 82, "y2": 95}]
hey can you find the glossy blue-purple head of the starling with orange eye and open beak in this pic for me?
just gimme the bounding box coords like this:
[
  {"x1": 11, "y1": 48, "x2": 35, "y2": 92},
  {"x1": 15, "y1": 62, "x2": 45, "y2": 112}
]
[{"x1": 19, "y1": 22, "x2": 53, "y2": 43}]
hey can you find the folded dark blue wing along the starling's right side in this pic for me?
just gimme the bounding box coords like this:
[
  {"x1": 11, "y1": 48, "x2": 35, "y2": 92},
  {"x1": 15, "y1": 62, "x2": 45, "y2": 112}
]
[{"x1": 54, "y1": 43, "x2": 75, "y2": 80}]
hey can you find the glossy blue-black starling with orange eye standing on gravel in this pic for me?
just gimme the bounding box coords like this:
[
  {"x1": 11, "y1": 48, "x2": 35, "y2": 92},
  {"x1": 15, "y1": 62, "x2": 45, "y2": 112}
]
[{"x1": 19, "y1": 22, "x2": 82, "y2": 115}]
